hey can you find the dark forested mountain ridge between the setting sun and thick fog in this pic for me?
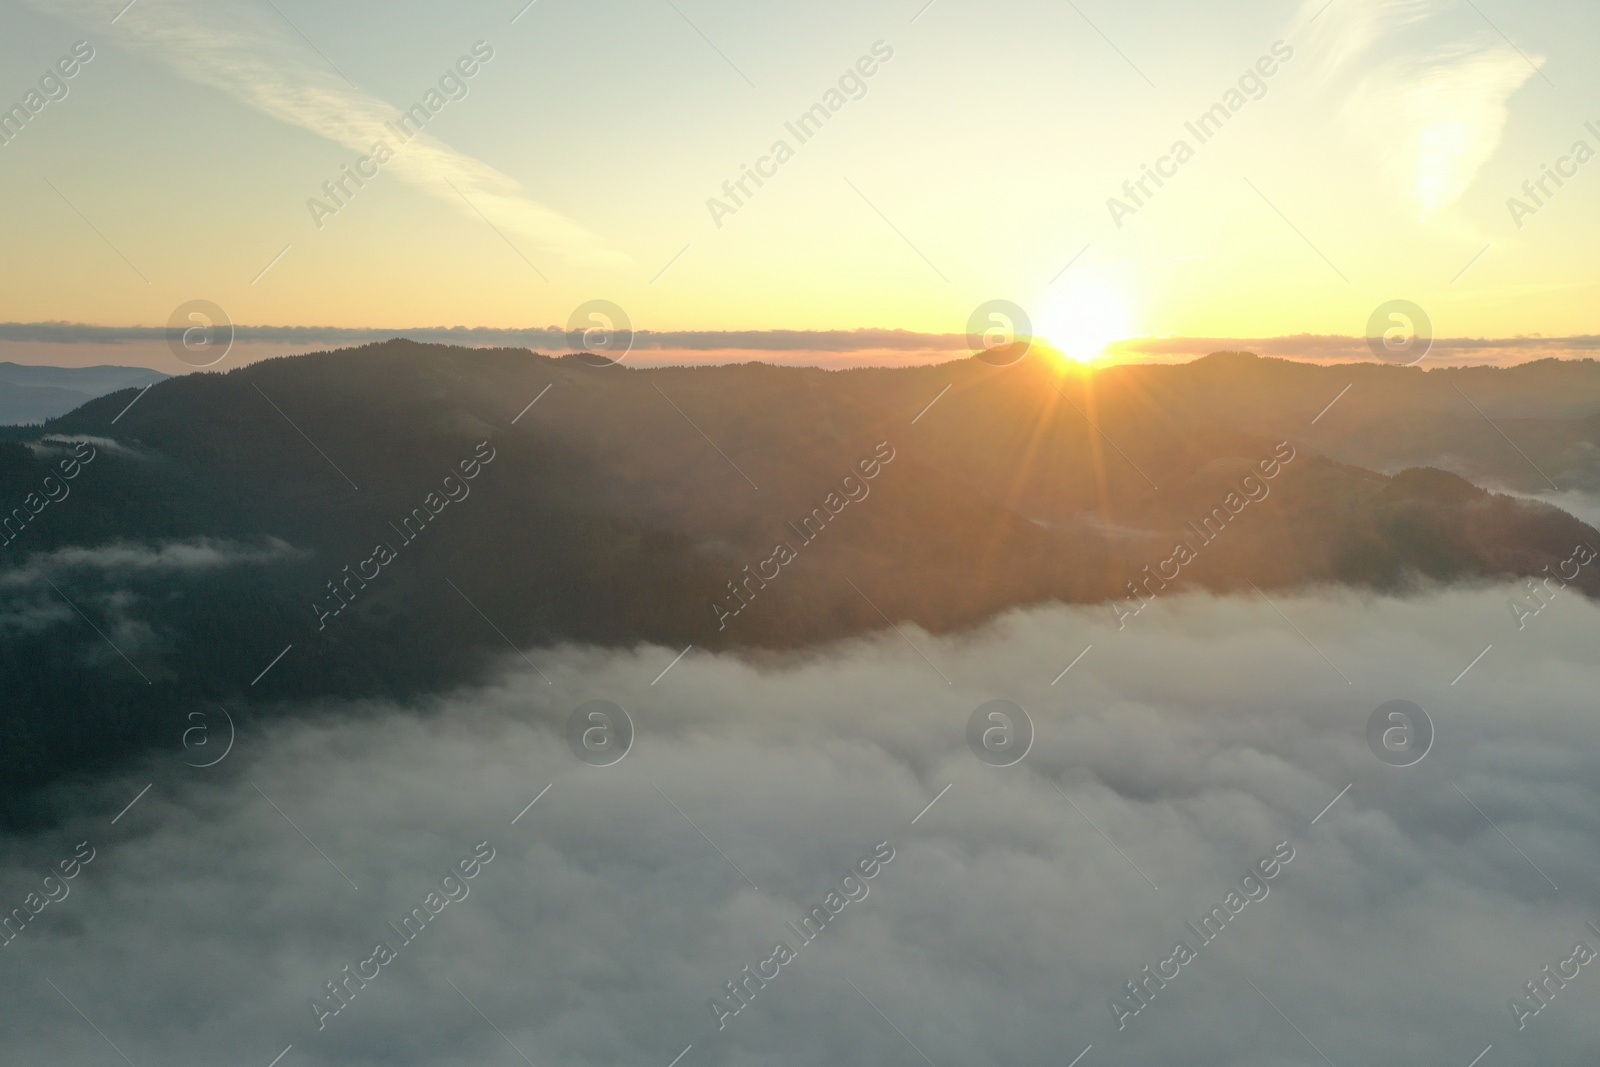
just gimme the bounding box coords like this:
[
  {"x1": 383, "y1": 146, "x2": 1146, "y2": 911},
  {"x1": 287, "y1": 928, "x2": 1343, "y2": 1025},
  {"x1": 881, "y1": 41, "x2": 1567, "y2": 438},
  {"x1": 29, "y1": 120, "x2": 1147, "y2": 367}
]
[{"x1": 0, "y1": 341, "x2": 1600, "y2": 814}]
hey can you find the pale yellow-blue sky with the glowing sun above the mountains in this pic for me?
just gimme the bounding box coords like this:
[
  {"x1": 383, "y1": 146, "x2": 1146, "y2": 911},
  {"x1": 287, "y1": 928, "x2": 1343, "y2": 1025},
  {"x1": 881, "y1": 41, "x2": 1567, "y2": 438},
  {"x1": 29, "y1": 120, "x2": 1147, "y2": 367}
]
[{"x1": 0, "y1": 0, "x2": 1600, "y2": 370}]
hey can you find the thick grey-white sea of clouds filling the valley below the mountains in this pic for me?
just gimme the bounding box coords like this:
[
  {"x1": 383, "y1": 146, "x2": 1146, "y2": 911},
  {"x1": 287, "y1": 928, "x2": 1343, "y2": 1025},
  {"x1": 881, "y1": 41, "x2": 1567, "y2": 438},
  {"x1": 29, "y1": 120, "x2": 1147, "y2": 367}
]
[{"x1": 0, "y1": 587, "x2": 1600, "y2": 1067}]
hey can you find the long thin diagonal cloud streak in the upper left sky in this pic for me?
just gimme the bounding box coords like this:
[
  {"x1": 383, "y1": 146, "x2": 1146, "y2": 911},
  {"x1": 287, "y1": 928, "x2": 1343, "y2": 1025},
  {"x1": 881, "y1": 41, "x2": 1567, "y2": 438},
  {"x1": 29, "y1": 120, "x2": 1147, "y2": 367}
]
[{"x1": 30, "y1": 0, "x2": 624, "y2": 262}]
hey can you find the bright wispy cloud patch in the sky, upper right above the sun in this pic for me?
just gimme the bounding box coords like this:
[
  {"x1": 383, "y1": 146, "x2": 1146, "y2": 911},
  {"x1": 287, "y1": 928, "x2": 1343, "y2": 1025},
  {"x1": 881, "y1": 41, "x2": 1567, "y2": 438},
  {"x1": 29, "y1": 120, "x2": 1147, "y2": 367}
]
[{"x1": 1306, "y1": 0, "x2": 1542, "y2": 219}]
